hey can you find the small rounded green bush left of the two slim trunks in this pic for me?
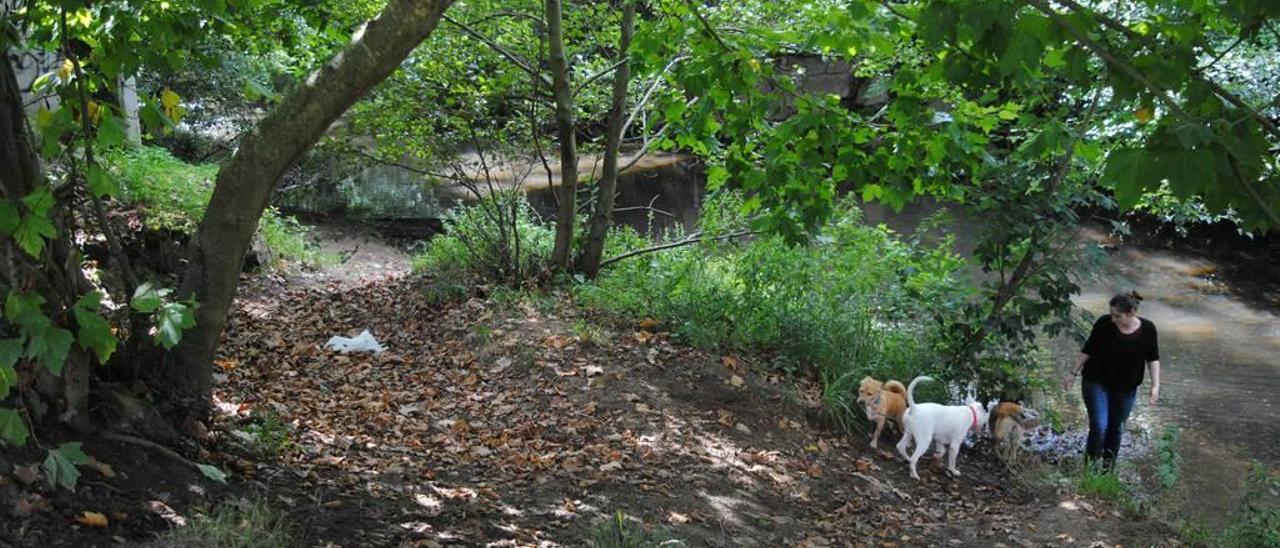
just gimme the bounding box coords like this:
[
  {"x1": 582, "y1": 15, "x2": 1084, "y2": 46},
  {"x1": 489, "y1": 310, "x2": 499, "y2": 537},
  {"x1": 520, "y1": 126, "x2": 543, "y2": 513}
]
[{"x1": 413, "y1": 192, "x2": 554, "y2": 287}]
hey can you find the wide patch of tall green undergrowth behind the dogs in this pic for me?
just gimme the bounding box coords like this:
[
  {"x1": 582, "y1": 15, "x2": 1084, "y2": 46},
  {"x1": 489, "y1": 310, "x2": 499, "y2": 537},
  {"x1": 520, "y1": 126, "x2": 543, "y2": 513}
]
[{"x1": 575, "y1": 192, "x2": 966, "y2": 420}]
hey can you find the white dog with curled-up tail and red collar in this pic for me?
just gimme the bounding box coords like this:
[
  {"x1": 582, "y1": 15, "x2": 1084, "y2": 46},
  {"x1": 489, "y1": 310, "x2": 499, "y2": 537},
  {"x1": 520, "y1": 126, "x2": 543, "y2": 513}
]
[{"x1": 897, "y1": 376, "x2": 987, "y2": 479}]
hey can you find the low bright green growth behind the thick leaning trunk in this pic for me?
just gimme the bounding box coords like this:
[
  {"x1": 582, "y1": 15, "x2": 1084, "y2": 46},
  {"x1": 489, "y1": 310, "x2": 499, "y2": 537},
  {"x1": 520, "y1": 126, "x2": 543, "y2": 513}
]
[{"x1": 105, "y1": 147, "x2": 337, "y2": 264}]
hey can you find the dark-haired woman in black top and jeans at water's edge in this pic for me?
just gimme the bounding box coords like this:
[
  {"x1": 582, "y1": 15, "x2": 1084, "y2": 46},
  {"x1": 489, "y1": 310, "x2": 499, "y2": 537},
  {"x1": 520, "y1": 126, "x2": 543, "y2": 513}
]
[{"x1": 1062, "y1": 292, "x2": 1160, "y2": 471}]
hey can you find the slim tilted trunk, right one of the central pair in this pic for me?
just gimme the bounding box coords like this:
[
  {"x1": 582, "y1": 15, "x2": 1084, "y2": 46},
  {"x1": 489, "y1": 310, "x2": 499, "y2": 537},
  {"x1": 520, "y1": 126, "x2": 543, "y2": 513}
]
[{"x1": 579, "y1": 0, "x2": 636, "y2": 279}]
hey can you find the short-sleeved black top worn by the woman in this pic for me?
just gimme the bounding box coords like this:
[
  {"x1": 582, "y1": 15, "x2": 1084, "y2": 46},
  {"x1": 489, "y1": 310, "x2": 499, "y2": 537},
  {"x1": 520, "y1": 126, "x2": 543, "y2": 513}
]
[{"x1": 1080, "y1": 315, "x2": 1160, "y2": 391}]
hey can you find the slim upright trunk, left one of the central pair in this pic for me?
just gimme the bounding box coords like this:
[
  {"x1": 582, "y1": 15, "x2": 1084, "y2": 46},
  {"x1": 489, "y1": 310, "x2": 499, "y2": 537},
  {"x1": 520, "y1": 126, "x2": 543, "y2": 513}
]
[{"x1": 545, "y1": 0, "x2": 577, "y2": 270}]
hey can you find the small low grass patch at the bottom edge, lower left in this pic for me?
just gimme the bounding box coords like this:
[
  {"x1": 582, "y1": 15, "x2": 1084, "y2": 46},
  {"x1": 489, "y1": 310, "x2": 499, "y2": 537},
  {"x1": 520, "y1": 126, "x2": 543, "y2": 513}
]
[{"x1": 163, "y1": 499, "x2": 297, "y2": 548}]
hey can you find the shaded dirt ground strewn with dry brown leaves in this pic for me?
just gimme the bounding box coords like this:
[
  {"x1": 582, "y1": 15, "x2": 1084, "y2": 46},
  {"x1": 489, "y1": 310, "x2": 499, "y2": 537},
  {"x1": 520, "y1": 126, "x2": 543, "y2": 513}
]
[{"x1": 0, "y1": 224, "x2": 1176, "y2": 547}]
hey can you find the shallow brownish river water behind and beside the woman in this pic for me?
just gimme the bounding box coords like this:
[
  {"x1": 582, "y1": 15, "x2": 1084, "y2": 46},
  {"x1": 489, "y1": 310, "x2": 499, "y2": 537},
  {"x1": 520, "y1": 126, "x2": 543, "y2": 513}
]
[{"x1": 1060, "y1": 225, "x2": 1280, "y2": 521}]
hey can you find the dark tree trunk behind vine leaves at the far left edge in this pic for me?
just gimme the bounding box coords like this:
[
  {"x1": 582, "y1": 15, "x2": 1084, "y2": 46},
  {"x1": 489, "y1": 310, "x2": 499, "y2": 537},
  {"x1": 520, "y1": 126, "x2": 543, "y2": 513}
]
[{"x1": 0, "y1": 55, "x2": 91, "y2": 431}]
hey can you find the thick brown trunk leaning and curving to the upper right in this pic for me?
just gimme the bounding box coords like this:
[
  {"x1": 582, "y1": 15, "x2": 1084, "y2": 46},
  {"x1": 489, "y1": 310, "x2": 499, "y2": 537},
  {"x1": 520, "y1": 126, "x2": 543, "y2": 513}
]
[{"x1": 165, "y1": 0, "x2": 452, "y2": 412}]
